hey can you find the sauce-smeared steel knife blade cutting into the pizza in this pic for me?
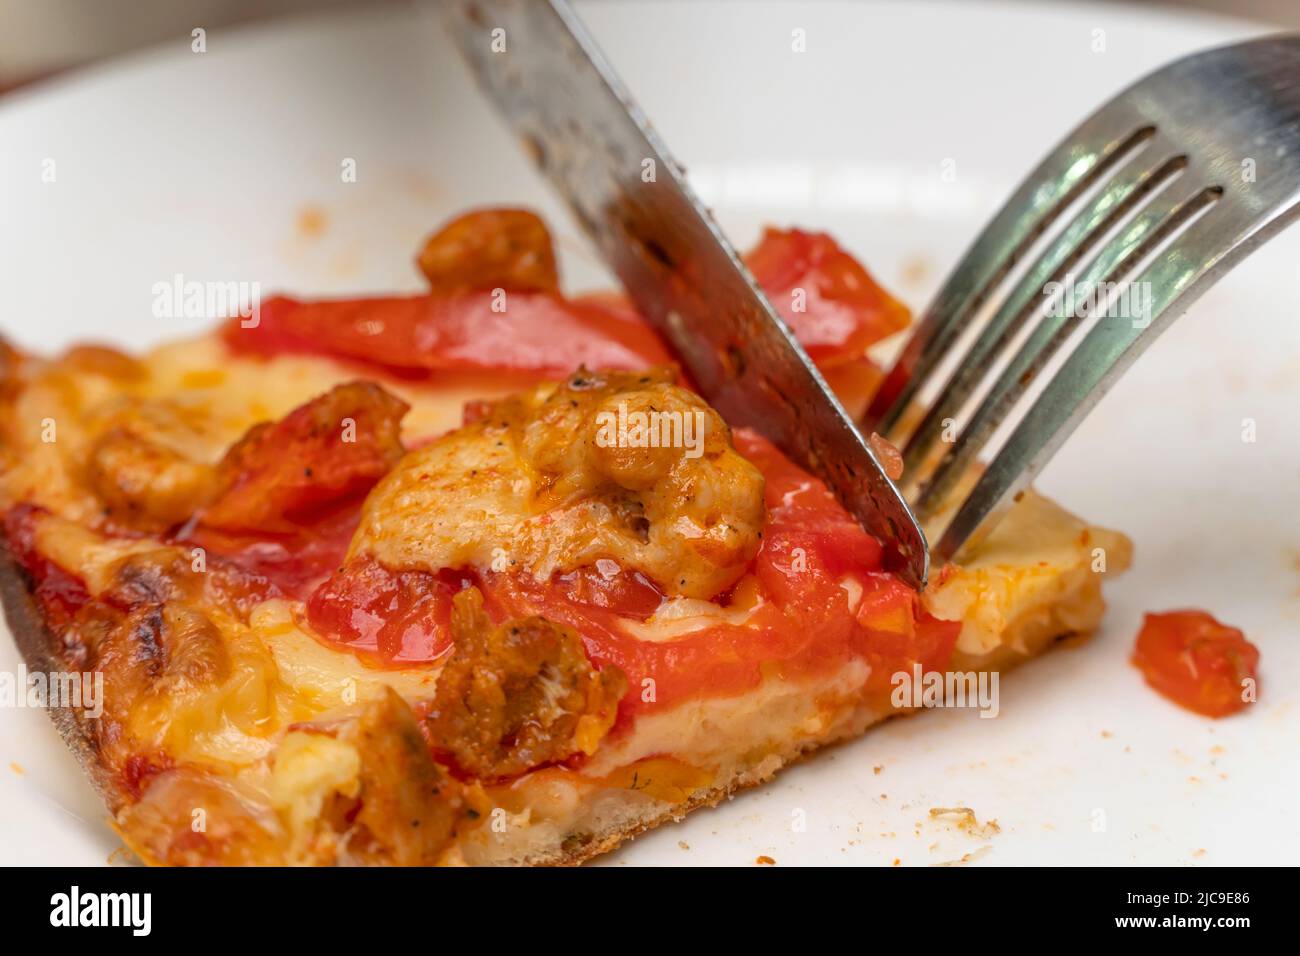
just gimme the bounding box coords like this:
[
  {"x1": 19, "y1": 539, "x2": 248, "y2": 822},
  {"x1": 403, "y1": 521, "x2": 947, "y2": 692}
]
[{"x1": 443, "y1": 0, "x2": 930, "y2": 589}]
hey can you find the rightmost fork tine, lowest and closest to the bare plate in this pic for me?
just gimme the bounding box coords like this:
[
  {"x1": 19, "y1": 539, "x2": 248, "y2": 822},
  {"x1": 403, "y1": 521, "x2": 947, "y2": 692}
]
[{"x1": 935, "y1": 190, "x2": 1300, "y2": 562}]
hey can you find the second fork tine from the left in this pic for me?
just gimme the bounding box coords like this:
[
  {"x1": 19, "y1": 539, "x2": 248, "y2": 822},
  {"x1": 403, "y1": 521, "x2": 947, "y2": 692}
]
[{"x1": 904, "y1": 137, "x2": 1186, "y2": 479}]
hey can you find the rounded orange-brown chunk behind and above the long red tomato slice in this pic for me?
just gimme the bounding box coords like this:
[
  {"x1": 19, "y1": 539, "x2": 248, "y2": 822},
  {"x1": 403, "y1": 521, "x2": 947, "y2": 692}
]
[{"x1": 420, "y1": 209, "x2": 559, "y2": 294}]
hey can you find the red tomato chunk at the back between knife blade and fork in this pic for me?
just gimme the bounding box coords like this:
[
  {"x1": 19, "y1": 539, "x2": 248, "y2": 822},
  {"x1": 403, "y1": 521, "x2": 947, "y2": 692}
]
[{"x1": 745, "y1": 229, "x2": 910, "y2": 368}]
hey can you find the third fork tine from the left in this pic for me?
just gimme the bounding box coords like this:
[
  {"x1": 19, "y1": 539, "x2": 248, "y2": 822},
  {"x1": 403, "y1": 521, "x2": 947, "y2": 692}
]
[{"x1": 914, "y1": 178, "x2": 1218, "y2": 520}]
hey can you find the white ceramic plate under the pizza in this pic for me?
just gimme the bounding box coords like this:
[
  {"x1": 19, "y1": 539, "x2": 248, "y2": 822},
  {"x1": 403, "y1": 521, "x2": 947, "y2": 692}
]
[{"x1": 0, "y1": 3, "x2": 1300, "y2": 865}]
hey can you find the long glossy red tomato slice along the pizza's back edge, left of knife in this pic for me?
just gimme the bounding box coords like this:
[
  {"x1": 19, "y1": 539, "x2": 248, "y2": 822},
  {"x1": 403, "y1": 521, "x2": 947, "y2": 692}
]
[{"x1": 222, "y1": 291, "x2": 672, "y2": 376}]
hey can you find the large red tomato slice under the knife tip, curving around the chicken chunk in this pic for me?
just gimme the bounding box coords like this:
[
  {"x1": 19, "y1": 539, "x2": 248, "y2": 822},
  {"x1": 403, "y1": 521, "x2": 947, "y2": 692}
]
[{"x1": 482, "y1": 429, "x2": 961, "y2": 718}]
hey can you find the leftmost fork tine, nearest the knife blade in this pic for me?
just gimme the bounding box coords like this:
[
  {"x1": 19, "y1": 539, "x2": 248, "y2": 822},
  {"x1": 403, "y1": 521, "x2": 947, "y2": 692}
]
[{"x1": 863, "y1": 117, "x2": 1153, "y2": 444}]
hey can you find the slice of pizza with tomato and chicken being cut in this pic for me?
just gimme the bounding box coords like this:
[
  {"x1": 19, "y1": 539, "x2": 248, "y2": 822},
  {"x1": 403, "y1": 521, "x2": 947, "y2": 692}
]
[{"x1": 0, "y1": 211, "x2": 1128, "y2": 865}]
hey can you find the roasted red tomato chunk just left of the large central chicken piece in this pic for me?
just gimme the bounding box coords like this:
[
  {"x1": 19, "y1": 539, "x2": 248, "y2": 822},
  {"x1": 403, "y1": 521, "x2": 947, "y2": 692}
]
[{"x1": 200, "y1": 382, "x2": 408, "y2": 533}]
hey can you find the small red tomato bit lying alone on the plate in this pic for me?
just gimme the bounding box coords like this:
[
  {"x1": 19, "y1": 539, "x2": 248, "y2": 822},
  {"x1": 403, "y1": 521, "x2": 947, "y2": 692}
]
[{"x1": 1132, "y1": 610, "x2": 1260, "y2": 717}]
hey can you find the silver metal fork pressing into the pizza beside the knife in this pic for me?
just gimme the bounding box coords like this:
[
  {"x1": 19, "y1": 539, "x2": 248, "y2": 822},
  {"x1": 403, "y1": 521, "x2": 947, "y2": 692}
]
[{"x1": 862, "y1": 36, "x2": 1300, "y2": 562}]
